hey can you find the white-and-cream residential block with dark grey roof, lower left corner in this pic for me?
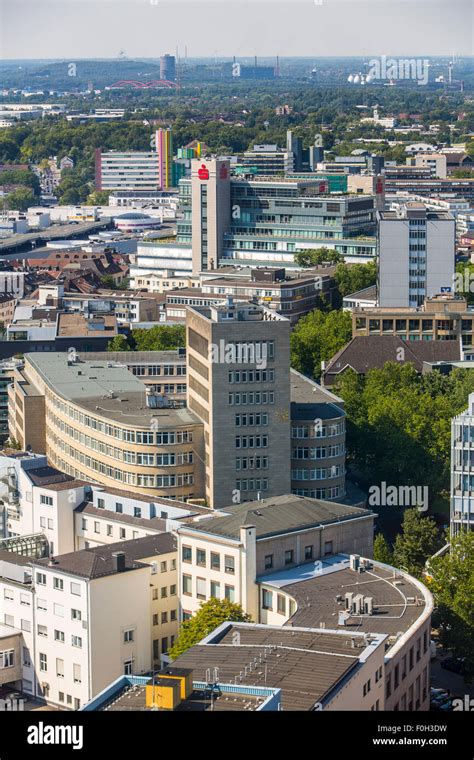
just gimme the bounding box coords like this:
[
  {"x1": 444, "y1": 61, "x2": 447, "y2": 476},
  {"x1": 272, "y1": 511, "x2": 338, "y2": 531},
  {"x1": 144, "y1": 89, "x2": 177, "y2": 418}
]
[{"x1": 0, "y1": 533, "x2": 178, "y2": 710}]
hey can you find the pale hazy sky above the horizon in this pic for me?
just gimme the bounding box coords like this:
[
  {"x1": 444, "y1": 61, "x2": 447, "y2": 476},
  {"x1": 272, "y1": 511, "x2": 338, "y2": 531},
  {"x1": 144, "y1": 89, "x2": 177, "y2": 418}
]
[{"x1": 0, "y1": 0, "x2": 474, "y2": 60}]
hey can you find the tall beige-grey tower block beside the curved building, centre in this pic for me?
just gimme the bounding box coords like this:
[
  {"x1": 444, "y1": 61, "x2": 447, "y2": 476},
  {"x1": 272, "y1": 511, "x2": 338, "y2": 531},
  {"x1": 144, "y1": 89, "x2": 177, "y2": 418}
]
[{"x1": 186, "y1": 299, "x2": 290, "y2": 508}]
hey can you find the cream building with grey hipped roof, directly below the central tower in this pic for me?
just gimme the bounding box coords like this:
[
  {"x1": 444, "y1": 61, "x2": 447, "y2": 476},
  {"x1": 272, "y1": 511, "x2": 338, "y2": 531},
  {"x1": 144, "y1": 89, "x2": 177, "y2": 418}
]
[{"x1": 177, "y1": 495, "x2": 375, "y2": 622}]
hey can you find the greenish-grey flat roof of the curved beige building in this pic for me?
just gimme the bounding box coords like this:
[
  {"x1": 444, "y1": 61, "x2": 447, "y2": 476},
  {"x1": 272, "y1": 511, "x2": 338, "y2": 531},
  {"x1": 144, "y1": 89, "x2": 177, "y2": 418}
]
[{"x1": 25, "y1": 352, "x2": 200, "y2": 430}]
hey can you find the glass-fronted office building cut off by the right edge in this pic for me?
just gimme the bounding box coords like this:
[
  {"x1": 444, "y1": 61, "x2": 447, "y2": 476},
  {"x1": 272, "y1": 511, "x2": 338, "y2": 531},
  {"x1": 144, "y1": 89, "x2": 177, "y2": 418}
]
[{"x1": 449, "y1": 393, "x2": 474, "y2": 535}]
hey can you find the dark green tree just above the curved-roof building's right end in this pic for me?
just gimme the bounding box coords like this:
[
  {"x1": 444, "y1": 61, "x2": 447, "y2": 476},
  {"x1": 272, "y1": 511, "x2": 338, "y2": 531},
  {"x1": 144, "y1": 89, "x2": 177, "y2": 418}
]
[{"x1": 393, "y1": 507, "x2": 441, "y2": 578}]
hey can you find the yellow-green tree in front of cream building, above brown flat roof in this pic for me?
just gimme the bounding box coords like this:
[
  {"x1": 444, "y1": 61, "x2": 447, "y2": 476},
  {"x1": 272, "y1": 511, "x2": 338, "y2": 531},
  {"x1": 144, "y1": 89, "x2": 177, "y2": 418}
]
[{"x1": 169, "y1": 598, "x2": 251, "y2": 660}]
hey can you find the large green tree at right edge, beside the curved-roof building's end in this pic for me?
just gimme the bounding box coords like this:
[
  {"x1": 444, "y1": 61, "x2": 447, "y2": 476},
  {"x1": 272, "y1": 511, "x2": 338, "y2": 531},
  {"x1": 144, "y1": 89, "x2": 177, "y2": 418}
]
[{"x1": 424, "y1": 531, "x2": 474, "y2": 680}]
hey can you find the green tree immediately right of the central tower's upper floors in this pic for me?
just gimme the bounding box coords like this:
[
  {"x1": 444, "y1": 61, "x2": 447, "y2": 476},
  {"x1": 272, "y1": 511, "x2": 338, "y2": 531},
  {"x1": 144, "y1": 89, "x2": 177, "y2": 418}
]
[{"x1": 290, "y1": 310, "x2": 352, "y2": 378}]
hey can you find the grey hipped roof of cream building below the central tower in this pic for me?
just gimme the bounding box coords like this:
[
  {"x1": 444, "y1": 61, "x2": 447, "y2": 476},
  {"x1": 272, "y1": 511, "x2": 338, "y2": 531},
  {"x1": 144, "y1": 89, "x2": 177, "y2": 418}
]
[{"x1": 186, "y1": 494, "x2": 375, "y2": 539}]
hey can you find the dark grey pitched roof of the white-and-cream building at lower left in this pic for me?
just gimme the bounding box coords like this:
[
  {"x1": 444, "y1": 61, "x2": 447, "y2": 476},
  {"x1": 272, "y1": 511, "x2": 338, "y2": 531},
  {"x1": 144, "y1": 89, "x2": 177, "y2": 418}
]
[{"x1": 31, "y1": 533, "x2": 176, "y2": 580}]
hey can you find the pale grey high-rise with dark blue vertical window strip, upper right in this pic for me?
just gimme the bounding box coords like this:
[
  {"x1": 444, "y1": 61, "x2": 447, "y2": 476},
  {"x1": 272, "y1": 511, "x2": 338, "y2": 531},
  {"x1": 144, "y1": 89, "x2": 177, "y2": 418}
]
[{"x1": 378, "y1": 203, "x2": 455, "y2": 308}]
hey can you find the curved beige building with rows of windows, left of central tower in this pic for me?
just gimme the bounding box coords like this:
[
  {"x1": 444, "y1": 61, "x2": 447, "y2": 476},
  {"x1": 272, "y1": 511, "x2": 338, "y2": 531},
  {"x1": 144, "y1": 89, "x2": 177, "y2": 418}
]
[{"x1": 9, "y1": 352, "x2": 204, "y2": 501}]
